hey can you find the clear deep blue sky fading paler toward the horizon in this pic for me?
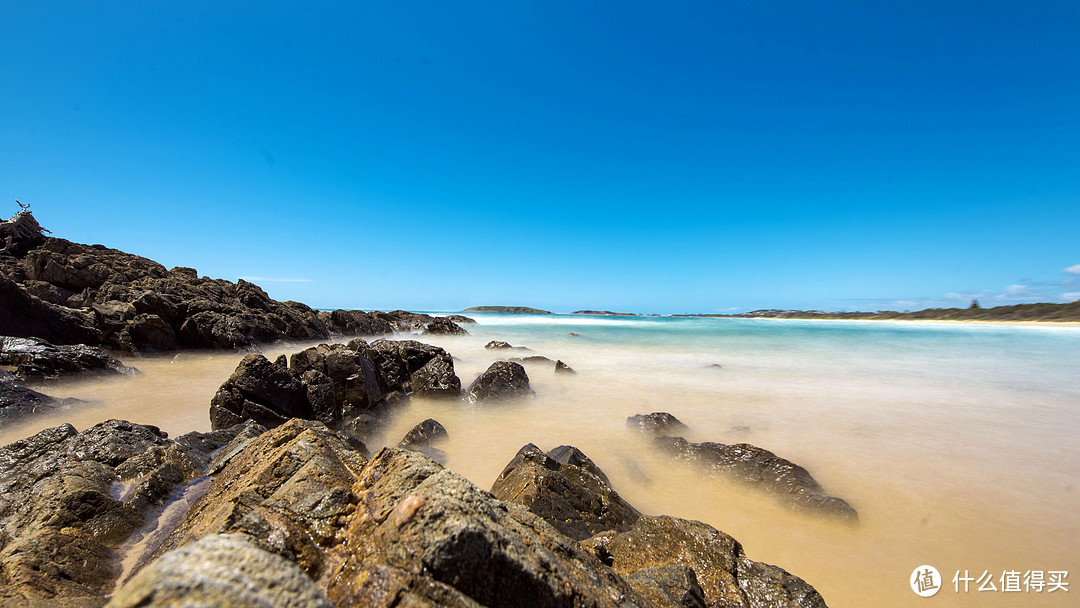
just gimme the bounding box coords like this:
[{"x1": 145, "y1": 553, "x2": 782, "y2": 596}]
[{"x1": 0, "y1": 0, "x2": 1080, "y2": 313}]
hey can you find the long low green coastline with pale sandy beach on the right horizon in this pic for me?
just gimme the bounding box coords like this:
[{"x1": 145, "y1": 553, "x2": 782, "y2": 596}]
[{"x1": 674, "y1": 300, "x2": 1080, "y2": 323}]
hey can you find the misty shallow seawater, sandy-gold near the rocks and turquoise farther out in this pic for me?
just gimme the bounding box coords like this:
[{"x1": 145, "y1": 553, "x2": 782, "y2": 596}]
[{"x1": 0, "y1": 315, "x2": 1080, "y2": 608}]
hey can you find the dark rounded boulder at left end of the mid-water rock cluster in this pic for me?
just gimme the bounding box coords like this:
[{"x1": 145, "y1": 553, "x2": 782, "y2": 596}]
[{"x1": 210, "y1": 353, "x2": 315, "y2": 429}]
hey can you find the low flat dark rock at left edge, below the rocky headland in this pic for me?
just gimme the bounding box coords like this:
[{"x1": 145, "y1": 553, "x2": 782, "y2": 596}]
[{"x1": 0, "y1": 336, "x2": 136, "y2": 381}]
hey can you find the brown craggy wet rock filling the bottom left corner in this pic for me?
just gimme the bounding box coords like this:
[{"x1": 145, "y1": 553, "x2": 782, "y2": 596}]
[{"x1": 0, "y1": 420, "x2": 248, "y2": 607}]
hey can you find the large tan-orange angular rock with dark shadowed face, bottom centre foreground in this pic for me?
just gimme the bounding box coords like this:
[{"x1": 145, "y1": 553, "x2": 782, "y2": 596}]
[{"x1": 320, "y1": 449, "x2": 646, "y2": 608}]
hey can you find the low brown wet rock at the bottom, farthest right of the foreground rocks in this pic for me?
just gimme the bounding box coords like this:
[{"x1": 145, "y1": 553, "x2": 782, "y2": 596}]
[{"x1": 582, "y1": 516, "x2": 825, "y2": 608}]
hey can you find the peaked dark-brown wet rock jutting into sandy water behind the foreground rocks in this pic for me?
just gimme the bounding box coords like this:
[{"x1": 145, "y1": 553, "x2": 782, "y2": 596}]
[{"x1": 491, "y1": 444, "x2": 642, "y2": 540}]
